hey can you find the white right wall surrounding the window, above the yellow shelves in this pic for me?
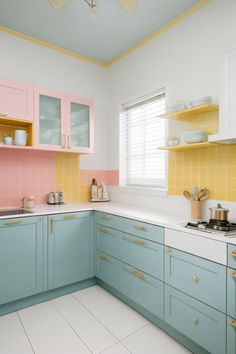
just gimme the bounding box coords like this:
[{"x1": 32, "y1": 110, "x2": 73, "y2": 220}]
[{"x1": 108, "y1": 0, "x2": 236, "y2": 216}]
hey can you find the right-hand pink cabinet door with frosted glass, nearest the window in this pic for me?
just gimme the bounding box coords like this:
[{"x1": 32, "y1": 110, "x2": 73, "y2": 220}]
[{"x1": 66, "y1": 96, "x2": 94, "y2": 153}]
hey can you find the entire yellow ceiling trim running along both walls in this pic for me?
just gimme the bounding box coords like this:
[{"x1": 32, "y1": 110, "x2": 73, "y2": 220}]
[{"x1": 0, "y1": 0, "x2": 212, "y2": 68}]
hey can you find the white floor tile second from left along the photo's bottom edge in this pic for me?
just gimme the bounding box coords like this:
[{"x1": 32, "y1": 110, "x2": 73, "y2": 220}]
[{"x1": 19, "y1": 302, "x2": 90, "y2": 354}]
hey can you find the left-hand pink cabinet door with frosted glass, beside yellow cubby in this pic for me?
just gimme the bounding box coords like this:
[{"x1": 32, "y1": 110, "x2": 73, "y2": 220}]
[{"x1": 34, "y1": 88, "x2": 66, "y2": 151}]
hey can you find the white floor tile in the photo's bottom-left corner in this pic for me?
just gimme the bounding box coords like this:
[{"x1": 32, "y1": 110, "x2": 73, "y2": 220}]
[{"x1": 0, "y1": 312, "x2": 33, "y2": 354}]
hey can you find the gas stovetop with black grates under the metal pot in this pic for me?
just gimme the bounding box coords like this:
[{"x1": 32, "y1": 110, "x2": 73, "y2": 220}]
[{"x1": 184, "y1": 219, "x2": 236, "y2": 237}]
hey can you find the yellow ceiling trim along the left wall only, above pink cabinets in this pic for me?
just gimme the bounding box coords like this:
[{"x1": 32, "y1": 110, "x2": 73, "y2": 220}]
[{"x1": 0, "y1": 26, "x2": 107, "y2": 68}]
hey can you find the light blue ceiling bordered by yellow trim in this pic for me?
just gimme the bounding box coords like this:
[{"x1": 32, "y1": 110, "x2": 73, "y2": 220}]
[{"x1": 0, "y1": 0, "x2": 198, "y2": 62}]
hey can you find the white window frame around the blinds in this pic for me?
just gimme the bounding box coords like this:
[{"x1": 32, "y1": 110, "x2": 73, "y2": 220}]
[{"x1": 119, "y1": 88, "x2": 168, "y2": 196}]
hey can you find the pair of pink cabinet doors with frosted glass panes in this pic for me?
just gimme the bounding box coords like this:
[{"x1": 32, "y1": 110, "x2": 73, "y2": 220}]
[{"x1": 35, "y1": 88, "x2": 94, "y2": 153}]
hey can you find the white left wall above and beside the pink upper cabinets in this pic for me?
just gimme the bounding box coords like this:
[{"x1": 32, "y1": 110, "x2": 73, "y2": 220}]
[{"x1": 0, "y1": 32, "x2": 109, "y2": 169}]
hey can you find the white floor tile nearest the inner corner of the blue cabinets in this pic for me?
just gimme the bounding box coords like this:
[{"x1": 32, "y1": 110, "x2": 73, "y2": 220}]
[{"x1": 73, "y1": 286, "x2": 149, "y2": 339}]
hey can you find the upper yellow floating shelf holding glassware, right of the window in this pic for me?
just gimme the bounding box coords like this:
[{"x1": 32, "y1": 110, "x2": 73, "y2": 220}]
[{"x1": 159, "y1": 104, "x2": 219, "y2": 120}]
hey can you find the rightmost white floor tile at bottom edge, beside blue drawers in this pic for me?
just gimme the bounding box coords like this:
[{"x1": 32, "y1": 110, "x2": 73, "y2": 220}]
[{"x1": 122, "y1": 324, "x2": 190, "y2": 354}]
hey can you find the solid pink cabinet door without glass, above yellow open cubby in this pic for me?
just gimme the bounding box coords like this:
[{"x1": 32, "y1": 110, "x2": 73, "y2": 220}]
[{"x1": 0, "y1": 79, "x2": 34, "y2": 121}]
